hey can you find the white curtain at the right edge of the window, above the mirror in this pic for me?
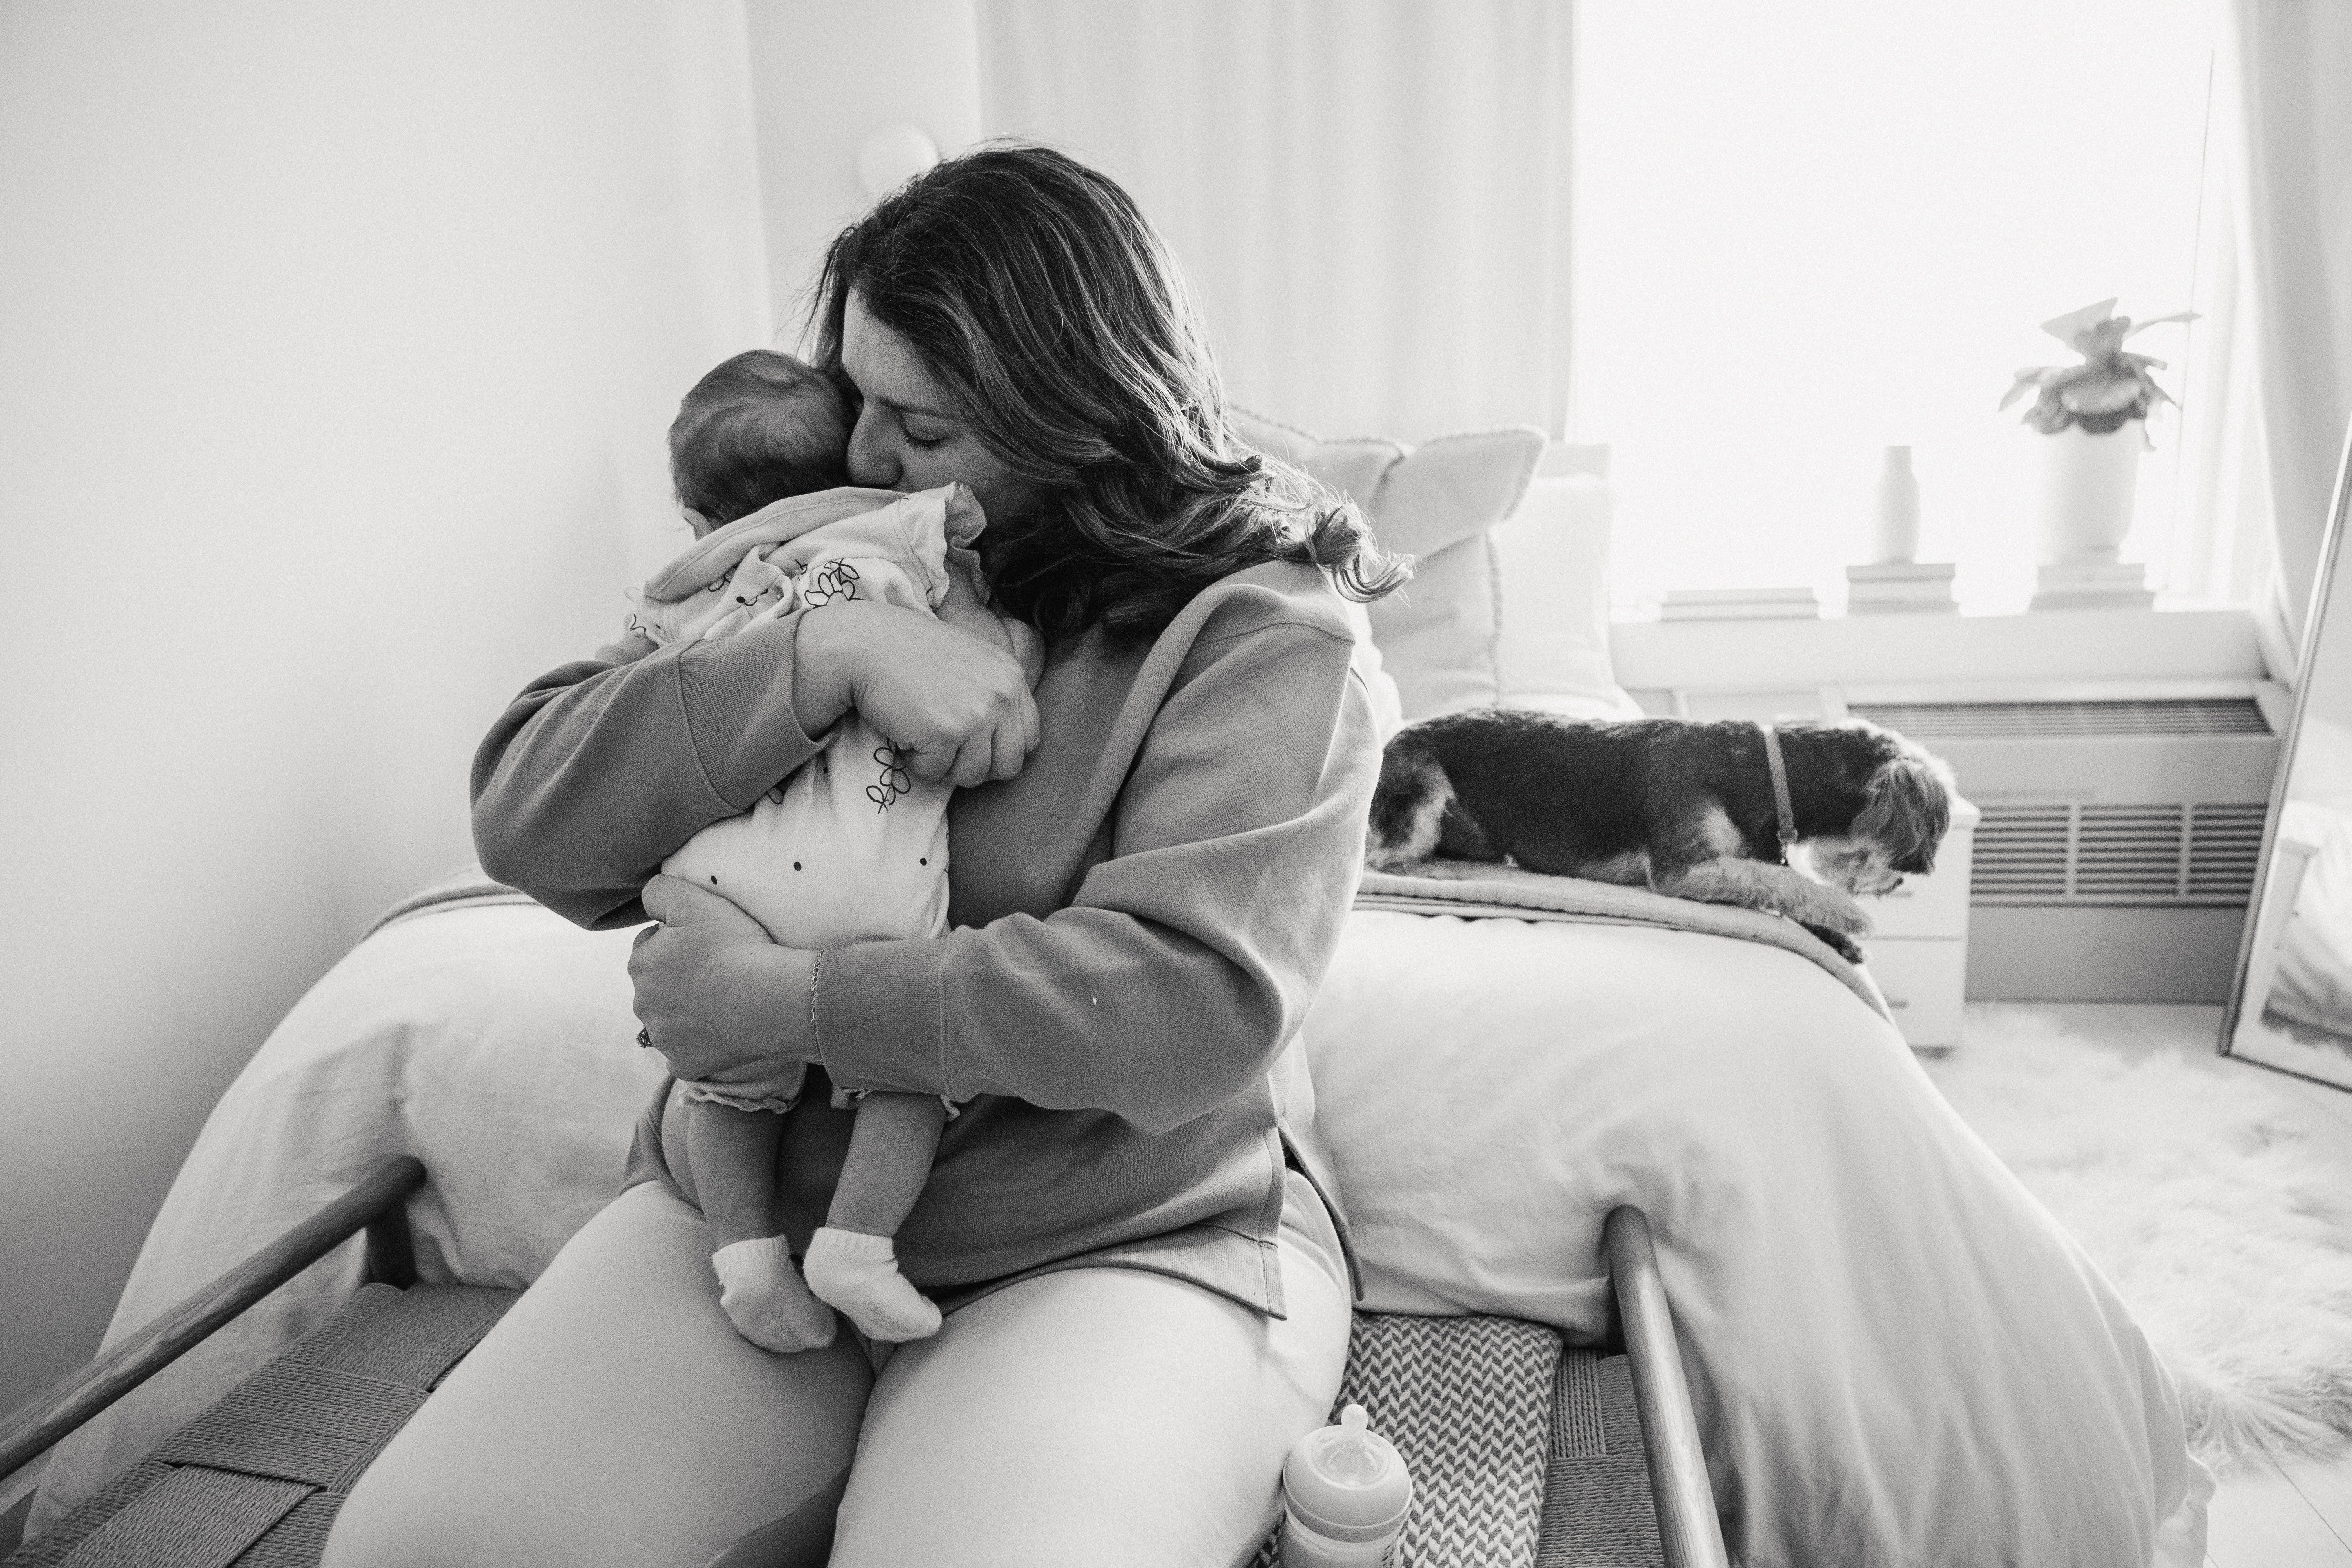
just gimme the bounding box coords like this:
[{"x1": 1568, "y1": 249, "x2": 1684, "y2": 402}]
[{"x1": 2223, "y1": 0, "x2": 2352, "y2": 639}]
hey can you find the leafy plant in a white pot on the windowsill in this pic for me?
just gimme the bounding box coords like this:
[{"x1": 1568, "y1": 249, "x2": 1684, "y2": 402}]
[{"x1": 2002, "y1": 299, "x2": 2197, "y2": 583}]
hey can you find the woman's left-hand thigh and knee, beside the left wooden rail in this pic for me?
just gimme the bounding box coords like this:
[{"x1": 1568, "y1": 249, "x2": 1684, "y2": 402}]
[{"x1": 327, "y1": 1187, "x2": 870, "y2": 1568}]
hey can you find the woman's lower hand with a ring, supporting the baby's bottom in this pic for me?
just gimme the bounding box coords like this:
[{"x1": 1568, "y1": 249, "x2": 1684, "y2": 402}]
[{"x1": 628, "y1": 877, "x2": 816, "y2": 1093}]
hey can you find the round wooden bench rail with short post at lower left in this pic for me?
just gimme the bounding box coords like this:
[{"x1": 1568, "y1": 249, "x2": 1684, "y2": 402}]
[{"x1": 0, "y1": 1154, "x2": 426, "y2": 1481}]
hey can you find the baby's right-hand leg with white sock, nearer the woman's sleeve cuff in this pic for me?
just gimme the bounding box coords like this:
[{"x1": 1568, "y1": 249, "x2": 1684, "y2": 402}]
[{"x1": 809, "y1": 1093, "x2": 948, "y2": 1340}]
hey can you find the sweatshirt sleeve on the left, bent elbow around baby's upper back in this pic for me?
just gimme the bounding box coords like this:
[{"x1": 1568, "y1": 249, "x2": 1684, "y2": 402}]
[{"x1": 473, "y1": 613, "x2": 821, "y2": 931}]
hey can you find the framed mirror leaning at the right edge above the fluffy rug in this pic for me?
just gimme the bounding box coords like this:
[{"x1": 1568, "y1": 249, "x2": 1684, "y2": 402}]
[{"x1": 2220, "y1": 432, "x2": 2352, "y2": 1089}]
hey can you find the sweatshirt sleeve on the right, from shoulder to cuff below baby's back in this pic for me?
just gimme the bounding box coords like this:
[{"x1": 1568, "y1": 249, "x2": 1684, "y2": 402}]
[{"x1": 816, "y1": 623, "x2": 1381, "y2": 1131}]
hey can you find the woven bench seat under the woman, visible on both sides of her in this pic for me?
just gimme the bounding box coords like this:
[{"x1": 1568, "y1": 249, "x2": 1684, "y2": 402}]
[{"x1": 23, "y1": 1286, "x2": 1663, "y2": 1568}]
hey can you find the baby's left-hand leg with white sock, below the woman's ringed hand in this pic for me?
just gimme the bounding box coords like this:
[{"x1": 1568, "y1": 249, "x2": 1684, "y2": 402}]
[{"x1": 687, "y1": 1100, "x2": 833, "y2": 1354}]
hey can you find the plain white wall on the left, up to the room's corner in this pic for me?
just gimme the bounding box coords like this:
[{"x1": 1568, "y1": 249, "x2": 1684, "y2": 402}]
[{"x1": 0, "y1": 0, "x2": 781, "y2": 1410}]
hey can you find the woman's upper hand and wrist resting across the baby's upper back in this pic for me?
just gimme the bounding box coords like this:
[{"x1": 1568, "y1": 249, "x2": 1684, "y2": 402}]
[{"x1": 793, "y1": 602, "x2": 1040, "y2": 788}]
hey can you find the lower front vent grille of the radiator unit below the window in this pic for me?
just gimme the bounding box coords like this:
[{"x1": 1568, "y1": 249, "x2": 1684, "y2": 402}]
[{"x1": 1969, "y1": 804, "x2": 2267, "y2": 907}]
